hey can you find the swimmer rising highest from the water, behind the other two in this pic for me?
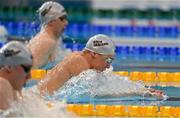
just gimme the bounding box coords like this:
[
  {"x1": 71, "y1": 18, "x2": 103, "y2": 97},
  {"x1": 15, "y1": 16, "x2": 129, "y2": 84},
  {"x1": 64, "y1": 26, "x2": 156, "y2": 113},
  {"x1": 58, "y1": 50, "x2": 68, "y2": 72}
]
[{"x1": 28, "y1": 1, "x2": 68, "y2": 68}]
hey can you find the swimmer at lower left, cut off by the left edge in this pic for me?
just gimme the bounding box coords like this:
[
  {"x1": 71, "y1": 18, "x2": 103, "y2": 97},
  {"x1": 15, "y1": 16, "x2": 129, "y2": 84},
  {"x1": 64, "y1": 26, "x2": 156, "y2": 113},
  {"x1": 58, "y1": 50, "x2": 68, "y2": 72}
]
[{"x1": 0, "y1": 41, "x2": 32, "y2": 110}]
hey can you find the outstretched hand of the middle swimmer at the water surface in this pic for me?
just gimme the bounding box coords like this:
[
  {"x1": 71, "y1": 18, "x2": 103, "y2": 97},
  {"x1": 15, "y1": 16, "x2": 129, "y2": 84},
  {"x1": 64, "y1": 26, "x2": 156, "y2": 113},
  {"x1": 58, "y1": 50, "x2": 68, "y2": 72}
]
[{"x1": 145, "y1": 88, "x2": 165, "y2": 99}]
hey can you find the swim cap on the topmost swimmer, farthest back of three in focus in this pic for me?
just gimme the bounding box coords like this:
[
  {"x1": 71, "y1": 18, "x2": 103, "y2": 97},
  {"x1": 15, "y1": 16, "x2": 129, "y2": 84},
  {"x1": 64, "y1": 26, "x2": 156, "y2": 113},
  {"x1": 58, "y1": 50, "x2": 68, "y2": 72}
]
[{"x1": 38, "y1": 1, "x2": 67, "y2": 25}]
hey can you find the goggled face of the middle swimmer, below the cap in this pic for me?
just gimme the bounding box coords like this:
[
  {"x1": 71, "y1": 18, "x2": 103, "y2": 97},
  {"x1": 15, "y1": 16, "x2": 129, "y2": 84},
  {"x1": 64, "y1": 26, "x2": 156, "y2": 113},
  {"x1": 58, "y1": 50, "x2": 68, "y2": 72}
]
[{"x1": 93, "y1": 53, "x2": 114, "y2": 71}]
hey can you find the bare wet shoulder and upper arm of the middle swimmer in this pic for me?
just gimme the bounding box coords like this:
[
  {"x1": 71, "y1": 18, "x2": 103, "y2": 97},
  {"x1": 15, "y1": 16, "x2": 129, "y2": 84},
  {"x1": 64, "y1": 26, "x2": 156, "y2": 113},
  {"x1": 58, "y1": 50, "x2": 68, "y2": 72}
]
[{"x1": 39, "y1": 56, "x2": 88, "y2": 94}]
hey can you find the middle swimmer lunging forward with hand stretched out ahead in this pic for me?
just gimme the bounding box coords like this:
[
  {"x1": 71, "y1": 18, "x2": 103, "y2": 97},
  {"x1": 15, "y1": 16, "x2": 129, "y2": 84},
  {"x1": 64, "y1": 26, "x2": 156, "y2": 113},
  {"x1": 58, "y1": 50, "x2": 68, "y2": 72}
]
[{"x1": 39, "y1": 34, "x2": 163, "y2": 97}]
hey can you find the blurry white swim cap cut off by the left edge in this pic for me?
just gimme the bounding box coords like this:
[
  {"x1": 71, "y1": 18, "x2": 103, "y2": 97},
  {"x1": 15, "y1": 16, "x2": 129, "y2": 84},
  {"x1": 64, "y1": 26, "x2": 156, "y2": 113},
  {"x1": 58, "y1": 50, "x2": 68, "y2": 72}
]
[{"x1": 0, "y1": 25, "x2": 8, "y2": 43}]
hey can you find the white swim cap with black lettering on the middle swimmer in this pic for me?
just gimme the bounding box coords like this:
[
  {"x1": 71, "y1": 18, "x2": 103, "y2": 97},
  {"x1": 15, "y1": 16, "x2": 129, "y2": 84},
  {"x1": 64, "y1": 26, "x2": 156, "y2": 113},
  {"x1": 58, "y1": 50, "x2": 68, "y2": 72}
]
[{"x1": 85, "y1": 34, "x2": 115, "y2": 55}]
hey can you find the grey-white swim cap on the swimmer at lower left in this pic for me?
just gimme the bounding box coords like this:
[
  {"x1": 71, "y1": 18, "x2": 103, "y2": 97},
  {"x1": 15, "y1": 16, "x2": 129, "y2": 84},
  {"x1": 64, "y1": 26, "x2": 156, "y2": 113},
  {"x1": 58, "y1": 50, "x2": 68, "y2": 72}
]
[{"x1": 0, "y1": 41, "x2": 32, "y2": 66}]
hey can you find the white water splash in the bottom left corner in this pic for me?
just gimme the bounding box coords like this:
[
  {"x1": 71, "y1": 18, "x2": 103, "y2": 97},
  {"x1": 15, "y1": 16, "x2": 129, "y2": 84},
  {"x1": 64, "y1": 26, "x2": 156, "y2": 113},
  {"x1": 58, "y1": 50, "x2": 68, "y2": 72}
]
[{"x1": 0, "y1": 87, "x2": 75, "y2": 118}]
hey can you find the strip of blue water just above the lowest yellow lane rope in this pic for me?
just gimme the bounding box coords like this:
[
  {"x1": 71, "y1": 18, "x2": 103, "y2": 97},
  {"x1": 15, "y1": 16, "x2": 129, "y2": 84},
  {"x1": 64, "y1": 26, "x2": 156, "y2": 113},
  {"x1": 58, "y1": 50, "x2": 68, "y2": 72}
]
[{"x1": 64, "y1": 86, "x2": 180, "y2": 106}]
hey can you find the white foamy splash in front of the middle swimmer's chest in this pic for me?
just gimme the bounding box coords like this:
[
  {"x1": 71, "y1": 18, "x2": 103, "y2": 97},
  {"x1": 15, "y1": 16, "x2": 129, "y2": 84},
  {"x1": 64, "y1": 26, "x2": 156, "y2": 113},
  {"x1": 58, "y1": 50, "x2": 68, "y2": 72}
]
[{"x1": 53, "y1": 67, "x2": 165, "y2": 99}]
